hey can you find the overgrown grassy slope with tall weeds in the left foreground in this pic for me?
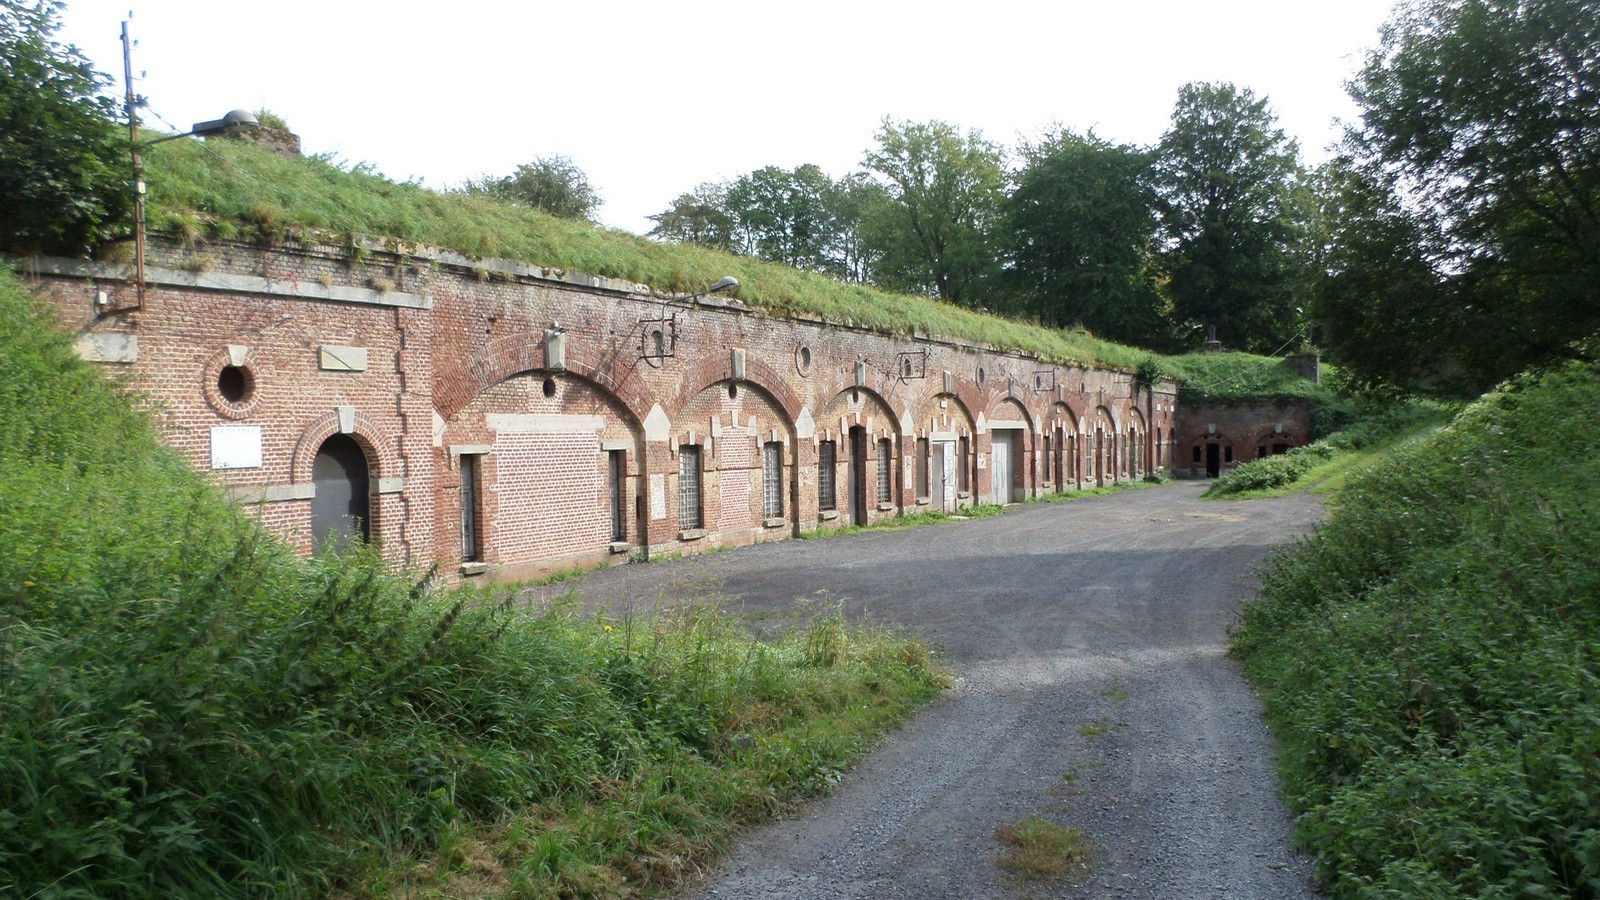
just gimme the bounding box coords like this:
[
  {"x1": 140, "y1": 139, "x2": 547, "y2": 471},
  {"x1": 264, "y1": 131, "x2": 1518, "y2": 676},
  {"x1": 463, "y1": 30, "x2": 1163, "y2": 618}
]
[{"x1": 0, "y1": 267, "x2": 944, "y2": 897}]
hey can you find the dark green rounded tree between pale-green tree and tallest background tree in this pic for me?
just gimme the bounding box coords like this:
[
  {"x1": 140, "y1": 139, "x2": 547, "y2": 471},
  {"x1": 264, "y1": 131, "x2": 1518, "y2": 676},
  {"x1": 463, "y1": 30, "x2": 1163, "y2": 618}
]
[{"x1": 1006, "y1": 130, "x2": 1168, "y2": 346}]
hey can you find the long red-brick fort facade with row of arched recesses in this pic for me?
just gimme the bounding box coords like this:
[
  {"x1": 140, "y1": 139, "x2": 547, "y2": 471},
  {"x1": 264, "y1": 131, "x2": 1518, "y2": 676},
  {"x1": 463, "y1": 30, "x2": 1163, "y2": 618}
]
[{"x1": 29, "y1": 235, "x2": 1177, "y2": 578}]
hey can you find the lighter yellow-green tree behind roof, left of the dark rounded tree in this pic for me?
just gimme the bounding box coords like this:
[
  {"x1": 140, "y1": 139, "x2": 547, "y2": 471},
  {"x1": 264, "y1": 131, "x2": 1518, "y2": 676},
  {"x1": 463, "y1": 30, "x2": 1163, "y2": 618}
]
[{"x1": 862, "y1": 119, "x2": 1005, "y2": 306}]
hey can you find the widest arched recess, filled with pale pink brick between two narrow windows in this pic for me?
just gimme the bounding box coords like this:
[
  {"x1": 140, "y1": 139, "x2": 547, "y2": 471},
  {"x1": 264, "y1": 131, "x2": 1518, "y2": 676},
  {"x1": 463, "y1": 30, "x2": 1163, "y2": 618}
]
[{"x1": 437, "y1": 367, "x2": 650, "y2": 573}]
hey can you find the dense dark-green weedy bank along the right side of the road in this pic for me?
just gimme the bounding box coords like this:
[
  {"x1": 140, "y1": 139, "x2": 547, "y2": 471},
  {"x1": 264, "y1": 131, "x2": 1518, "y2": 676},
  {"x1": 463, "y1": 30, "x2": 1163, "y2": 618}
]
[{"x1": 1234, "y1": 353, "x2": 1600, "y2": 897}]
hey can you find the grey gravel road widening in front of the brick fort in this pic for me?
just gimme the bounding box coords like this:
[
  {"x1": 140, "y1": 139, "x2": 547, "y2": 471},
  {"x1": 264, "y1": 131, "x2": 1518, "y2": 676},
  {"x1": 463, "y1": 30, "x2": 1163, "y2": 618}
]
[{"x1": 563, "y1": 484, "x2": 1318, "y2": 900}]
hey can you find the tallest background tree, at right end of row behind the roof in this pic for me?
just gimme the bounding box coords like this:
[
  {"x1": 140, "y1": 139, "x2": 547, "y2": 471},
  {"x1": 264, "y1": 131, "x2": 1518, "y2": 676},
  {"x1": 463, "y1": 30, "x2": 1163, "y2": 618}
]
[{"x1": 1157, "y1": 83, "x2": 1299, "y2": 351}]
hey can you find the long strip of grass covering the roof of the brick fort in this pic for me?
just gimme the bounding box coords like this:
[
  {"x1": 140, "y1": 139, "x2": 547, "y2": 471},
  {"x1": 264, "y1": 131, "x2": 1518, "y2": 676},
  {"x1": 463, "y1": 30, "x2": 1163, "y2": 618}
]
[{"x1": 146, "y1": 141, "x2": 1152, "y2": 372}]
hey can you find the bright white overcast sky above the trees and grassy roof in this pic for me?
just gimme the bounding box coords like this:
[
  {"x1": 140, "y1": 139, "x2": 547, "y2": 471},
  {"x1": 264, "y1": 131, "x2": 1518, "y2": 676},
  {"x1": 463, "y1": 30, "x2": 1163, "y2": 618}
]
[{"x1": 59, "y1": 0, "x2": 1392, "y2": 234}]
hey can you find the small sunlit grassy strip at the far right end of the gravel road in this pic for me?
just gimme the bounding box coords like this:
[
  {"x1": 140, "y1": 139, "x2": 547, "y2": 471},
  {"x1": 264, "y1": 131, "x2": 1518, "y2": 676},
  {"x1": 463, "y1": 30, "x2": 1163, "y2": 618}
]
[{"x1": 1203, "y1": 399, "x2": 1450, "y2": 500}]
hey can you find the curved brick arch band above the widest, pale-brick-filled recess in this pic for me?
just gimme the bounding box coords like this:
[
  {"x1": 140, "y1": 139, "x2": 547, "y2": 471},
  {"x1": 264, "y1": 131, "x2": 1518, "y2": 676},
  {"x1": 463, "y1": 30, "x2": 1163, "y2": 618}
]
[{"x1": 434, "y1": 335, "x2": 656, "y2": 428}]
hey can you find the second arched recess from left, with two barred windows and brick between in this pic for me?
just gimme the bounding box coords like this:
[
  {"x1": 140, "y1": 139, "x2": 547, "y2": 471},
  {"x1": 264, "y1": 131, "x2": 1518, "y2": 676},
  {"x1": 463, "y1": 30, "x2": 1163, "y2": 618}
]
[{"x1": 667, "y1": 378, "x2": 798, "y2": 544}]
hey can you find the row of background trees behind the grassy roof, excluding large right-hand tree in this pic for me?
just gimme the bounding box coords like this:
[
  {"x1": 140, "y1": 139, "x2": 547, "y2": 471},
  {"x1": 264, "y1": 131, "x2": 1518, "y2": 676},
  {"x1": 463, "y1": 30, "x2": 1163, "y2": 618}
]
[{"x1": 650, "y1": 83, "x2": 1310, "y2": 351}]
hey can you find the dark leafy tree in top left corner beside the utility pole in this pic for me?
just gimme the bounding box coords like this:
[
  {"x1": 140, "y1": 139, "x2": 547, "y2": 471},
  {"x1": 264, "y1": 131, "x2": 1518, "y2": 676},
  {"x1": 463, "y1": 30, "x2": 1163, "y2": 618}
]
[{"x1": 0, "y1": 0, "x2": 133, "y2": 253}]
